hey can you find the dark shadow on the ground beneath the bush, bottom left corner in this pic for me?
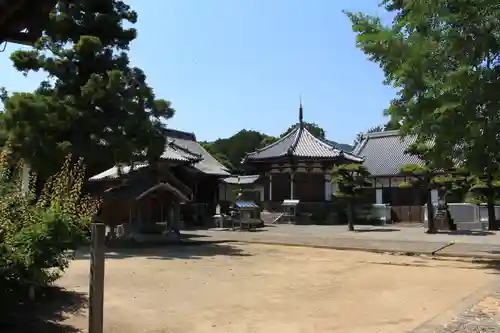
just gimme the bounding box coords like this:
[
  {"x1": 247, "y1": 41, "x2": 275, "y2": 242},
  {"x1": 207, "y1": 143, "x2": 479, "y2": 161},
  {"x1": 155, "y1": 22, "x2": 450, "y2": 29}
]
[{"x1": 0, "y1": 287, "x2": 87, "y2": 333}]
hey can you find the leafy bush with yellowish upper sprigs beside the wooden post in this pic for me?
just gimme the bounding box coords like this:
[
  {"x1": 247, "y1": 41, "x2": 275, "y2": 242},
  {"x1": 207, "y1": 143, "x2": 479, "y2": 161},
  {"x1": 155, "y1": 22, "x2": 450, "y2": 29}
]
[{"x1": 0, "y1": 155, "x2": 98, "y2": 314}]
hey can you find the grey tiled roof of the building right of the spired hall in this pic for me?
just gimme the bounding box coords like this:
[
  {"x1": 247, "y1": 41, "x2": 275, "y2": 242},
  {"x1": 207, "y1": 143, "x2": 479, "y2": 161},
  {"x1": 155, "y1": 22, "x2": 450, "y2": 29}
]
[{"x1": 354, "y1": 131, "x2": 423, "y2": 176}]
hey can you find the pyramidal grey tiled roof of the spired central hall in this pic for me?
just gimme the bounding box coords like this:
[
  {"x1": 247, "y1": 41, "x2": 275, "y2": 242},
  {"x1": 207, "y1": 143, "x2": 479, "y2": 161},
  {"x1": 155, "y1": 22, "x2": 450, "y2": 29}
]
[{"x1": 246, "y1": 125, "x2": 363, "y2": 162}]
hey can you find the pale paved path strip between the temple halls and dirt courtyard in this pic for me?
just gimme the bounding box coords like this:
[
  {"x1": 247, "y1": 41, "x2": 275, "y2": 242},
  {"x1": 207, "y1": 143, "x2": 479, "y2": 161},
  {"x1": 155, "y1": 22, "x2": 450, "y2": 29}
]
[{"x1": 188, "y1": 225, "x2": 500, "y2": 259}]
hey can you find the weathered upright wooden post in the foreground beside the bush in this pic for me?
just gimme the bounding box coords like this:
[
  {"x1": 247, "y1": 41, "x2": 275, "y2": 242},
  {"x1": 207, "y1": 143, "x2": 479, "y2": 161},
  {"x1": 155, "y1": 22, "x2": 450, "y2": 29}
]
[{"x1": 89, "y1": 223, "x2": 106, "y2": 333}]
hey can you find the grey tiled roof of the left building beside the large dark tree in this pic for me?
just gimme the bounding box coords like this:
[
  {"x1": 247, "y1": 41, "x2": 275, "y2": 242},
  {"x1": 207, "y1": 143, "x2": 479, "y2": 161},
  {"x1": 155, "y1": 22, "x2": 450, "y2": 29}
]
[{"x1": 167, "y1": 129, "x2": 230, "y2": 176}]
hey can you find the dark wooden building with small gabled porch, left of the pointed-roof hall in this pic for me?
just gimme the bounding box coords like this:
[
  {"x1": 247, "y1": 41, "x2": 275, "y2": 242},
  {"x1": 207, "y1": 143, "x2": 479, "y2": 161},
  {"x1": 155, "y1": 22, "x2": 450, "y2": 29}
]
[{"x1": 89, "y1": 130, "x2": 229, "y2": 230}]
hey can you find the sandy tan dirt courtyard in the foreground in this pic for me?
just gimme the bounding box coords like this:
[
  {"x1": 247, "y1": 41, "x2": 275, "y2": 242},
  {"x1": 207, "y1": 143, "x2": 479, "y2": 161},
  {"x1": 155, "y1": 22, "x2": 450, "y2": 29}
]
[{"x1": 59, "y1": 244, "x2": 497, "y2": 333}]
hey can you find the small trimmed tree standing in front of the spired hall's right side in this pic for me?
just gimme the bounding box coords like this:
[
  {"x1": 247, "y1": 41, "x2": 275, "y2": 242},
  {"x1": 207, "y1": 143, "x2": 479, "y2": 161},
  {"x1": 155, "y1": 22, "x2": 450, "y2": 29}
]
[{"x1": 332, "y1": 163, "x2": 371, "y2": 231}]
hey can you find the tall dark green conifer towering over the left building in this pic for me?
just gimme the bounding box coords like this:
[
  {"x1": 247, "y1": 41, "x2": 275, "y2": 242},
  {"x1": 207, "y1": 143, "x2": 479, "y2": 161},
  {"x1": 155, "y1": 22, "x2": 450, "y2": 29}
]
[{"x1": 1, "y1": 0, "x2": 174, "y2": 178}]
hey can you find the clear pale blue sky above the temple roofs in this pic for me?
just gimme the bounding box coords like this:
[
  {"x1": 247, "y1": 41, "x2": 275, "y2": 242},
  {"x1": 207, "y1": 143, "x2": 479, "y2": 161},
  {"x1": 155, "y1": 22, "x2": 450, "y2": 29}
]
[{"x1": 0, "y1": 0, "x2": 394, "y2": 143}]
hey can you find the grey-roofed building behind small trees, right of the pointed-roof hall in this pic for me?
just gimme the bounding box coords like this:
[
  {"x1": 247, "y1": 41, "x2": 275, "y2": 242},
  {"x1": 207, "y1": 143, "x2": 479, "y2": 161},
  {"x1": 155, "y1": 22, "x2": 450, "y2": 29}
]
[{"x1": 354, "y1": 131, "x2": 438, "y2": 222}]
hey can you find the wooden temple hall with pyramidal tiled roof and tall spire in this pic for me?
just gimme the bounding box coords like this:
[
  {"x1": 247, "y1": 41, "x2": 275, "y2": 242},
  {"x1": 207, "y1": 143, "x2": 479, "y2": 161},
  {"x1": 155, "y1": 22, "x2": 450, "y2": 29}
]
[{"x1": 244, "y1": 103, "x2": 363, "y2": 210}]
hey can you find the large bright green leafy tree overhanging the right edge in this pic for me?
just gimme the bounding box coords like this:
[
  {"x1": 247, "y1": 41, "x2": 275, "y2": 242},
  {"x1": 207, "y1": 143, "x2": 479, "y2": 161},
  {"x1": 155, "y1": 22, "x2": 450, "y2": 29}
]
[{"x1": 348, "y1": 0, "x2": 500, "y2": 229}]
